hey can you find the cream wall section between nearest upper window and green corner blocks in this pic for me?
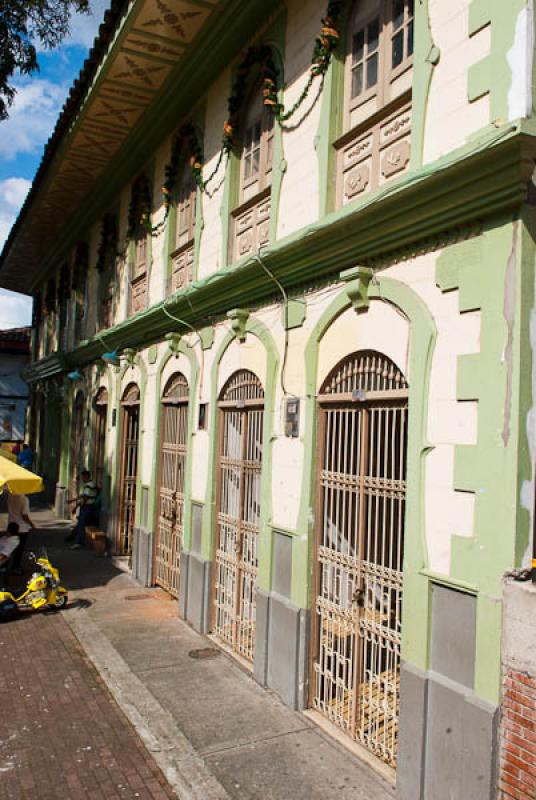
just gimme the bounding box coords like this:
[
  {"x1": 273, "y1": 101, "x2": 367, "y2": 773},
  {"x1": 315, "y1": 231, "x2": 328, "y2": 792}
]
[{"x1": 424, "y1": 0, "x2": 491, "y2": 163}]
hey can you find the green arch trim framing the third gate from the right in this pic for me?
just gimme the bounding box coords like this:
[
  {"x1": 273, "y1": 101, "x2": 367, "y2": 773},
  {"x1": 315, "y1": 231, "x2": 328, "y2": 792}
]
[{"x1": 147, "y1": 340, "x2": 199, "y2": 564}]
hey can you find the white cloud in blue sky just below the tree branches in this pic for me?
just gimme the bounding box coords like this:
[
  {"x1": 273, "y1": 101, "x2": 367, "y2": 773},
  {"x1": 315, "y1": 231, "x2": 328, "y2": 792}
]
[{"x1": 0, "y1": 79, "x2": 68, "y2": 161}]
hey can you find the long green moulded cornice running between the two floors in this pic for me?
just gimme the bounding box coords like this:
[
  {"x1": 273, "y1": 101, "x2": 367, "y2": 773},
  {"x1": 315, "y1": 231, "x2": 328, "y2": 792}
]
[{"x1": 24, "y1": 125, "x2": 536, "y2": 370}]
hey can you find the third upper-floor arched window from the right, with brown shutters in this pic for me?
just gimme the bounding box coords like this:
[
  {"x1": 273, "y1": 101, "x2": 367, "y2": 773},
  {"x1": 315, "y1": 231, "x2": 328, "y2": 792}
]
[{"x1": 169, "y1": 158, "x2": 197, "y2": 292}]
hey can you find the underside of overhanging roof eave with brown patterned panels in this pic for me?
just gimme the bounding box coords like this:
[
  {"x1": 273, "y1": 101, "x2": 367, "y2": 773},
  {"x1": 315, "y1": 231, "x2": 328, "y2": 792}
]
[{"x1": 0, "y1": 0, "x2": 279, "y2": 294}]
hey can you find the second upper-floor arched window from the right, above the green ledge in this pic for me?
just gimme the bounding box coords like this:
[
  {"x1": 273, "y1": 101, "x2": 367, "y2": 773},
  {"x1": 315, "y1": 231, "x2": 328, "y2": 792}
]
[{"x1": 230, "y1": 84, "x2": 274, "y2": 261}]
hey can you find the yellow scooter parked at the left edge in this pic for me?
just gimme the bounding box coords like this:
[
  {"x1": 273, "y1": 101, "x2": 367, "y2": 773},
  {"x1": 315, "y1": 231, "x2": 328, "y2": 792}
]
[{"x1": 0, "y1": 553, "x2": 69, "y2": 620}]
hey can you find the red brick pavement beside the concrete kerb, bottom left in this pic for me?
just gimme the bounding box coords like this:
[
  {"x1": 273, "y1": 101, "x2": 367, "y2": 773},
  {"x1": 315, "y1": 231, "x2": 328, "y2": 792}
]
[{"x1": 0, "y1": 613, "x2": 176, "y2": 800}]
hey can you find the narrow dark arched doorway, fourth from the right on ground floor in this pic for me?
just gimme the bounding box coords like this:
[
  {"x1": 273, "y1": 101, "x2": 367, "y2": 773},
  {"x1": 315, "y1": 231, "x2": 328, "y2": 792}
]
[{"x1": 117, "y1": 383, "x2": 140, "y2": 555}]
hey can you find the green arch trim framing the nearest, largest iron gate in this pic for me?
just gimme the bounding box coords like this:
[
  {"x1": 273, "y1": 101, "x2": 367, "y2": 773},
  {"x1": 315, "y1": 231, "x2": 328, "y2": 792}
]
[{"x1": 292, "y1": 277, "x2": 437, "y2": 669}]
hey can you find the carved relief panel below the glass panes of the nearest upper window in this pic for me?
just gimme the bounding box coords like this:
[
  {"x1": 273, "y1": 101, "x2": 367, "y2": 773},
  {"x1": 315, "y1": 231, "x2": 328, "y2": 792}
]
[{"x1": 336, "y1": 104, "x2": 411, "y2": 206}]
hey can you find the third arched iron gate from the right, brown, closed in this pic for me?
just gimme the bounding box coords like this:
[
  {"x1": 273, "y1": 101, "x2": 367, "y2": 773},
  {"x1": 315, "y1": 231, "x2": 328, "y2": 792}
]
[{"x1": 155, "y1": 373, "x2": 188, "y2": 597}]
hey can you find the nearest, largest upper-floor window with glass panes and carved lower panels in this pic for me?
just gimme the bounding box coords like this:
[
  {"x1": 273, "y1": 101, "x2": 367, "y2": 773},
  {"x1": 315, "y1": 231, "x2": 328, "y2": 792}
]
[{"x1": 336, "y1": 0, "x2": 414, "y2": 205}]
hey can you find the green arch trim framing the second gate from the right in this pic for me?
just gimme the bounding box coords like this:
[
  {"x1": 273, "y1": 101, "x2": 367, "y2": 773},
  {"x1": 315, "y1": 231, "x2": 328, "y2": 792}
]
[{"x1": 201, "y1": 317, "x2": 279, "y2": 589}]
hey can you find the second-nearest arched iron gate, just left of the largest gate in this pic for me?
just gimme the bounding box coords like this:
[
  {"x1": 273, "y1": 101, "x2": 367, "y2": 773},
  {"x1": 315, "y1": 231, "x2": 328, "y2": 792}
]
[{"x1": 214, "y1": 370, "x2": 264, "y2": 661}]
